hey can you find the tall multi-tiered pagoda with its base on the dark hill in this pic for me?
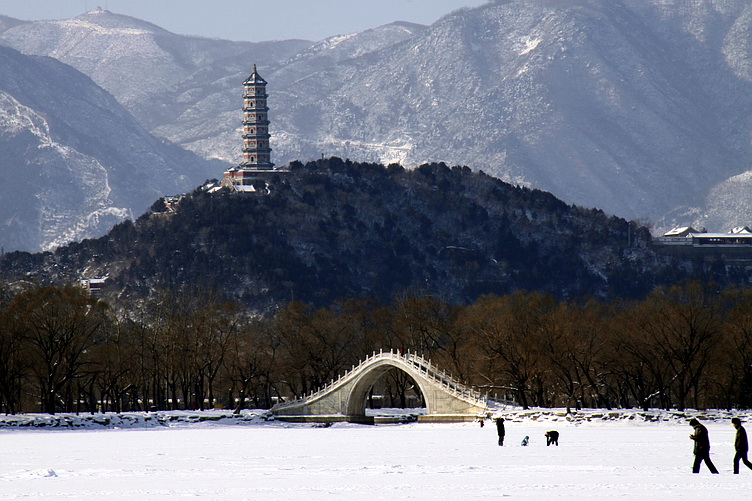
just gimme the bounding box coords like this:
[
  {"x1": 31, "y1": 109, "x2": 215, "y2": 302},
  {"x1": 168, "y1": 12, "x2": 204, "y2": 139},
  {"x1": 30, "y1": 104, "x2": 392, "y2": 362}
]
[{"x1": 222, "y1": 64, "x2": 287, "y2": 192}]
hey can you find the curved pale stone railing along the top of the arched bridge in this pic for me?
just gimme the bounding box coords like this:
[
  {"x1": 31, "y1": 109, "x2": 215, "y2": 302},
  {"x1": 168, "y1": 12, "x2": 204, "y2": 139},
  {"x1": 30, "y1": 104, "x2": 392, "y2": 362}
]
[{"x1": 274, "y1": 350, "x2": 487, "y2": 409}]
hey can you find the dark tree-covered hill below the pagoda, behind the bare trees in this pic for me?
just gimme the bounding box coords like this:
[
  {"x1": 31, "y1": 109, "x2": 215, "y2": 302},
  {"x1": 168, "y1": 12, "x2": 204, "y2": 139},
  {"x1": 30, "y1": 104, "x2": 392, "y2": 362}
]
[{"x1": 0, "y1": 158, "x2": 744, "y2": 311}]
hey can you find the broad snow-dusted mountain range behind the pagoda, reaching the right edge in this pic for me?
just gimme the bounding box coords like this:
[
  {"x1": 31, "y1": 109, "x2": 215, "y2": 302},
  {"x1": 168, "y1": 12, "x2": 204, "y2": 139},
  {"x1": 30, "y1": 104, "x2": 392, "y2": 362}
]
[{"x1": 0, "y1": 0, "x2": 752, "y2": 234}]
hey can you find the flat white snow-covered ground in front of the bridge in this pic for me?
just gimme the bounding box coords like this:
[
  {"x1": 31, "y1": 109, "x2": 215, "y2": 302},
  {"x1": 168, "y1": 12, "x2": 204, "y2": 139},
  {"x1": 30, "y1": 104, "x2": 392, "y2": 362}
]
[{"x1": 0, "y1": 412, "x2": 752, "y2": 501}]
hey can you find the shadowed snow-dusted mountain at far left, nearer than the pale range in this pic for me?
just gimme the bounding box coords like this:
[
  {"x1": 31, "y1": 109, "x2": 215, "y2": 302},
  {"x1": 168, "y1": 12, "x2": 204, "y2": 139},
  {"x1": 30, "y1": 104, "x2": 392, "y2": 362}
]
[{"x1": 0, "y1": 46, "x2": 216, "y2": 251}]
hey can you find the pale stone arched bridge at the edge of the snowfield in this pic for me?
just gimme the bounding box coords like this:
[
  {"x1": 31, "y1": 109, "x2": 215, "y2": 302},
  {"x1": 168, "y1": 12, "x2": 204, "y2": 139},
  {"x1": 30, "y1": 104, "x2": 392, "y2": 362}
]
[{"x1": 271, "y1": 351, "x2": 488, "y2": 423}]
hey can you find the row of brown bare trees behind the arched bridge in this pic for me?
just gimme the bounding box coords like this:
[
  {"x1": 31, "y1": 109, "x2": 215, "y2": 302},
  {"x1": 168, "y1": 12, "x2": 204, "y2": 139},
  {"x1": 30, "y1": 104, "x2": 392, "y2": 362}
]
[{"x1": 0, "y1": 283, "x2": 752, "y2": 413}]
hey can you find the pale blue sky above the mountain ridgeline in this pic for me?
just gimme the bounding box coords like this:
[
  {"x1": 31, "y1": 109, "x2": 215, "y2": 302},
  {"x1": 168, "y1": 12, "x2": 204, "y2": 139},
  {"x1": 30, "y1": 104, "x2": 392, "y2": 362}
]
[{"x1": 0, "y1": 0, "x2": 487, "y2": 42}]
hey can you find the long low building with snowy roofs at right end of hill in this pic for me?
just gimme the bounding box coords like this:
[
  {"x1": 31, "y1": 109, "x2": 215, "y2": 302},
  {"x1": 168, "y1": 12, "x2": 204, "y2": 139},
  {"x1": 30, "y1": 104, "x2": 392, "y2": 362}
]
[{"x1": 653, "y1": 226, "x2": 752, "y2": 264}]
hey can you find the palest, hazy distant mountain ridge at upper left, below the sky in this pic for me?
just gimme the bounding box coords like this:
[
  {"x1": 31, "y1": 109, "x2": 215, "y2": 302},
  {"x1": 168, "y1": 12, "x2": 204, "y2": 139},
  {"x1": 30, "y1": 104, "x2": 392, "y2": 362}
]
[{"x1": 0, "y1": 11, "x2": 309, "y2": 107}]
